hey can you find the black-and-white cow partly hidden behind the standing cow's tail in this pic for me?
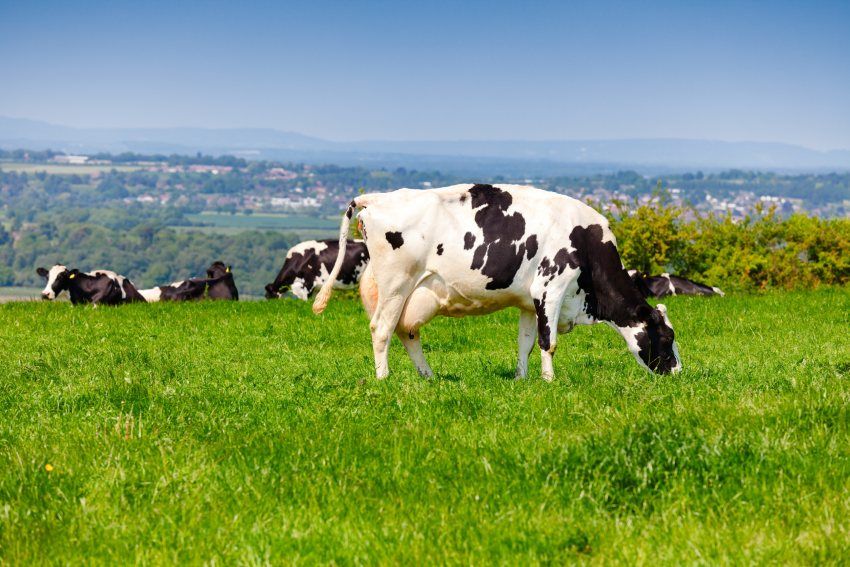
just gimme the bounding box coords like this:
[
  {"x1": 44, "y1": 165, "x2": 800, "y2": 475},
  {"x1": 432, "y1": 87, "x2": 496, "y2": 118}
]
[{"x1": 266, "y1": 239, "x2": 369, "y2": 301}]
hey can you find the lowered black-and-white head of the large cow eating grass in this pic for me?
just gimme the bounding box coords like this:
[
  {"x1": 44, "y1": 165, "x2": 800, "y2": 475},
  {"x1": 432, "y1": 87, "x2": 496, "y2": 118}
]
[{"x1": 619, "y1": 303, "x2": 682, "y2": 374}]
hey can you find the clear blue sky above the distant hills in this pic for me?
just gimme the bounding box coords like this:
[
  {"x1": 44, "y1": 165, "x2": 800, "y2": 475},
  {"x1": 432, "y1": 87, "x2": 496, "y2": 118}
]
[{"x1": 0, "y1": 0, "x2": 850, "y2": 149}]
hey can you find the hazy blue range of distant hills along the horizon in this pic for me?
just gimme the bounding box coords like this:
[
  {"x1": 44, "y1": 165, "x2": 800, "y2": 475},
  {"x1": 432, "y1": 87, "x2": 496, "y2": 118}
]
[{"x1": 0, "y1": 117, "x2": 850, "y2": 175}]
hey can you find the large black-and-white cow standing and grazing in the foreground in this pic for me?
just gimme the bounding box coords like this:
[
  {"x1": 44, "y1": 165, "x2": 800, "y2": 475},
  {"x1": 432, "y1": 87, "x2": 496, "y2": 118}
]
[{"x1": 313, "y1": 185, "x2": 682, "y2": 380}]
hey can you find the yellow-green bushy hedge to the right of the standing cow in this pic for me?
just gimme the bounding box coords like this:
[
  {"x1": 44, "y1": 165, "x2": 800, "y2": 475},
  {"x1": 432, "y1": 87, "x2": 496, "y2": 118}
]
[{"x1": 608, "y1": 196, "x2": 850, "y2": 290}]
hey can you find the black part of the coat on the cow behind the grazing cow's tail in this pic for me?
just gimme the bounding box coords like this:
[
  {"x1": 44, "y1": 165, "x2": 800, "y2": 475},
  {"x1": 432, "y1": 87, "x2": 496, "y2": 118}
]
[{"x1": 266, "y1": 240, "x2": 369, "y2": 299}]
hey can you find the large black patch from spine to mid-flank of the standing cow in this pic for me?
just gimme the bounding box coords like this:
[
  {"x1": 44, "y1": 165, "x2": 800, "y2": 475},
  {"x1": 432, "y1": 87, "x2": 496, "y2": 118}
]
[{"x1": 469, "y1": 185, "x2": 526, "y2": 289}]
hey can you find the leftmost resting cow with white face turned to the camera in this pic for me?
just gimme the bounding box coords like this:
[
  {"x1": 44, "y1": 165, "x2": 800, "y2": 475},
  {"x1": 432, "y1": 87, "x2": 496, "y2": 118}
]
[{"x1": 36, "y1": 264, "x2": 145, "y2": 305}]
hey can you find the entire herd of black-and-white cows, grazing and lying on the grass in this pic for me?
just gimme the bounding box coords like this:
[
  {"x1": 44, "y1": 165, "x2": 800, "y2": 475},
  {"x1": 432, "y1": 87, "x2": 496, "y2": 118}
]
[{"x1": 37, "y1": 184, "x2": 723, "y2": 380}]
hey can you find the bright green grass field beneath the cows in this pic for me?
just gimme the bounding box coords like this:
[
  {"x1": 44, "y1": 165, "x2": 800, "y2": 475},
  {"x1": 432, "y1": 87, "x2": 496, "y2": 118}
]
[{"x1": 0, "y1": 290, "x2": 850, "y2": 565}]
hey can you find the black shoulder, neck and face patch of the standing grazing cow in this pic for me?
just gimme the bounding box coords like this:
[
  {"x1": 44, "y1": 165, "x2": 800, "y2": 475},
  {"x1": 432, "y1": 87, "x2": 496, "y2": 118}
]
[{"x1": 569, "y1": 224, "x2": 676, "y2": 373}]
